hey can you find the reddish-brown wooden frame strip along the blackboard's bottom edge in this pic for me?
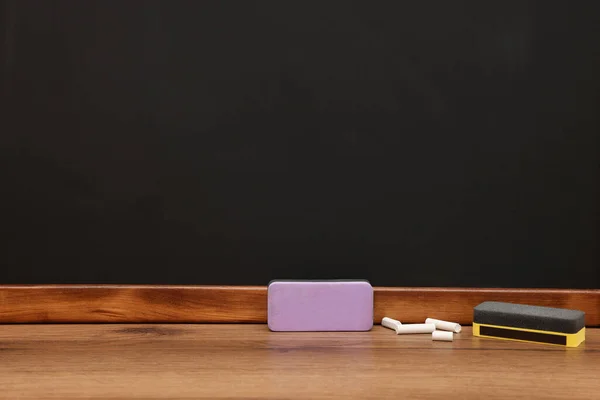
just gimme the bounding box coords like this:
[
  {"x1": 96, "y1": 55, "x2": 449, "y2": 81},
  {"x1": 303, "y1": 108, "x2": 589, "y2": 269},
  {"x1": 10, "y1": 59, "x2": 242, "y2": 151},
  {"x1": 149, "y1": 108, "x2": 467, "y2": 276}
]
[{"x1": 0, "y1": 285, "x2": 600, "y2": 326}]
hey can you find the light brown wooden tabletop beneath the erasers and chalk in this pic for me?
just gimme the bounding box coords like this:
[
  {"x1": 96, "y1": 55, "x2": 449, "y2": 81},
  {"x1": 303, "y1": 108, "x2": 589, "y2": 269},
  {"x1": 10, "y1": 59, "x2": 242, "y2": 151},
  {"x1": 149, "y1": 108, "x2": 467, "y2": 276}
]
[{"x1": 0, "y1": 325, "x2": 600, "y2": 400}]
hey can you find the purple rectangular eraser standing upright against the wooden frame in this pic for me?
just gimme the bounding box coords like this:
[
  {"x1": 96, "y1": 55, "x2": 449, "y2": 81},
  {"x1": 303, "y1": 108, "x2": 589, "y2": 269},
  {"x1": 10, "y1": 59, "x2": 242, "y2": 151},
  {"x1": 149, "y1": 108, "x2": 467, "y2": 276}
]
[{"x1": 267, "y1": 280, "x2": 373, "y2": 332}]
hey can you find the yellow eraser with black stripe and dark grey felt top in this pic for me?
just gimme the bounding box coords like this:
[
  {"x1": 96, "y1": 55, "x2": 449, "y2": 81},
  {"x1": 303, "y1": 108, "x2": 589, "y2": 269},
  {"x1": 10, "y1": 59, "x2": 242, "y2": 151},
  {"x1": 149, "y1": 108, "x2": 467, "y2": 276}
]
[{"x1": 473, "y1": 301, "x2": 585, "y2": 347}]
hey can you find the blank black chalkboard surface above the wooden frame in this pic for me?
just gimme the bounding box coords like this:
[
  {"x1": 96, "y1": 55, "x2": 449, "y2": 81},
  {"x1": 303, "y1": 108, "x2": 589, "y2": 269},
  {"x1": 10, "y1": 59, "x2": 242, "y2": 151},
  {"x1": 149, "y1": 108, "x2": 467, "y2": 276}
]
[{"x1": 0, "y1": 0, "x2": 600, "y2": 288}]
